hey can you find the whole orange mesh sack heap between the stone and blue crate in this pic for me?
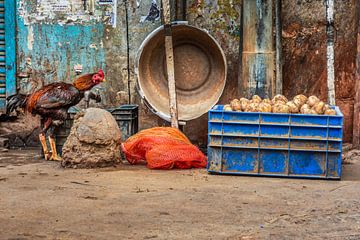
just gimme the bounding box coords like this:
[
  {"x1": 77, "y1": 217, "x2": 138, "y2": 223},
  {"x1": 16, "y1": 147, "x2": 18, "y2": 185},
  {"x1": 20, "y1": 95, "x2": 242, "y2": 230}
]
[{"x1": 121, "y1": 127, "x2": 207, "y2": 169}]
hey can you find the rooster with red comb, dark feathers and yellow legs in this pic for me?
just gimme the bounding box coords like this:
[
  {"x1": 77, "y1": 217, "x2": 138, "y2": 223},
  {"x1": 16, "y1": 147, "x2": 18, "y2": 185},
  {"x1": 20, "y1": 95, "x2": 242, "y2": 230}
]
[{"x1": 6, "y1": 70, "x2": 105, "y2": 161}]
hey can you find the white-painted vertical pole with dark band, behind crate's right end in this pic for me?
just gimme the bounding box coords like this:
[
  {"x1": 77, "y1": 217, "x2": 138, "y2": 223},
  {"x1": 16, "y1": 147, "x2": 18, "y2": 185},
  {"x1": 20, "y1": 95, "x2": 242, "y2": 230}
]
[{"x1": 326, "y1": 0, "x2": 336, "y2": 105}]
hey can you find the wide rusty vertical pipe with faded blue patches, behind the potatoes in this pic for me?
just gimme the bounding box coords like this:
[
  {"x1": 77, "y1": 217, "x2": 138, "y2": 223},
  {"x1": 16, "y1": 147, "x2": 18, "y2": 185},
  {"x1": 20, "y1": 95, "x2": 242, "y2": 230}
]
[{"x1": 241, "y1": 0, "x2": 275, "y2": 98}]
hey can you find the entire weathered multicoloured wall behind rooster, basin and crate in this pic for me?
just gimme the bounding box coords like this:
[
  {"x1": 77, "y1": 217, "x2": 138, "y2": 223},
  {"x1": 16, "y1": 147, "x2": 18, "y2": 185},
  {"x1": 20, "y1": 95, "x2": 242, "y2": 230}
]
[{"x1": 9, "y1": 0, "x2": 357, "y2": 145}]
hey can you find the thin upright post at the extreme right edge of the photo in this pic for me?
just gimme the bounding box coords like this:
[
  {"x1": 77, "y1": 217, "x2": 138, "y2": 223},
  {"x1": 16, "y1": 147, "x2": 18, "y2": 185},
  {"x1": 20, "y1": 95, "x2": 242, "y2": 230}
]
[{"x1": 353, "y1": 2, "x2": 360, "y2": 148}]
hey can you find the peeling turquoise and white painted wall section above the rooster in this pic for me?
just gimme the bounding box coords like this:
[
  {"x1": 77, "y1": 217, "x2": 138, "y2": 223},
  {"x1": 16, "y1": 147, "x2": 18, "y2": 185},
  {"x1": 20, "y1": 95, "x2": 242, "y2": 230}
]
[{"x1": 17, "y1": 0, "x2": 106, "y2": 92}]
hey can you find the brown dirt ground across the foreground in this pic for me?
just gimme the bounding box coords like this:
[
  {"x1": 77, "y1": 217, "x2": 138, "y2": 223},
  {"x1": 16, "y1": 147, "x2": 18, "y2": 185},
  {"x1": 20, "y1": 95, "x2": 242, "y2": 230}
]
[{"x1": 0, "y1": 150, "x2": 360, "y2": 240}]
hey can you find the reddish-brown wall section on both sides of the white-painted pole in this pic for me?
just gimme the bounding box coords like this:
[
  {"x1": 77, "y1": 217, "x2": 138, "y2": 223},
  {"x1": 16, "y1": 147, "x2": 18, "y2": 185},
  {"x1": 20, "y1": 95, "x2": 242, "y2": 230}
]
[{"x1": 282, "y1": 0, "x2": 359, "y2": 141}]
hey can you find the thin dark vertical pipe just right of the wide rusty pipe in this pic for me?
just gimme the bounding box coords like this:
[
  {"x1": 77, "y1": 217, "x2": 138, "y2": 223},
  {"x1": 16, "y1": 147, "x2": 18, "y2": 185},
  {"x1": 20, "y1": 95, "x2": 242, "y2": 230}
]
[{"x1": 275, "y1": 0, "x2": 283, "y2": 94}]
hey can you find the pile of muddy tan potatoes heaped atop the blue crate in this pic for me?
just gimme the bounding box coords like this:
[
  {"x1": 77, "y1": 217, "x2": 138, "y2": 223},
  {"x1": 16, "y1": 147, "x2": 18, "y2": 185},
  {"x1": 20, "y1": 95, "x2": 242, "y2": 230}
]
[{"x1": 224, "y1": 94, "x2": 336, "y2": 115}]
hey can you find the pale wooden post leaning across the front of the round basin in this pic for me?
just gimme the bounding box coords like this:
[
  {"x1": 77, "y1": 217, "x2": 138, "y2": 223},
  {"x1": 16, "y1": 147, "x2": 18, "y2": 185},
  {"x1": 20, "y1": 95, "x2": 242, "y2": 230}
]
[{"x1": 162, "y1": 0, "x2": 179, "y2": 128}]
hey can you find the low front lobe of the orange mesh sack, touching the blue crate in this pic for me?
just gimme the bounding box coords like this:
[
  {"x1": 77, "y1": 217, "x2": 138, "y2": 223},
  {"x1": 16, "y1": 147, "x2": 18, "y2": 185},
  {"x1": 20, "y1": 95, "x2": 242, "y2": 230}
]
[{"x1": 146, "y1": 144, "x2": 207, "y2": 169}]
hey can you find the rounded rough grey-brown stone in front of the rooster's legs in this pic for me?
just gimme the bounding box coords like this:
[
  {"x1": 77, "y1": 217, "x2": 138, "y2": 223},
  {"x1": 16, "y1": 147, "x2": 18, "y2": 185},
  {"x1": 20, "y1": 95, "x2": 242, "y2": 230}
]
[{"x1": 62, "y1": 108, "x2": 121, "y2": 168}]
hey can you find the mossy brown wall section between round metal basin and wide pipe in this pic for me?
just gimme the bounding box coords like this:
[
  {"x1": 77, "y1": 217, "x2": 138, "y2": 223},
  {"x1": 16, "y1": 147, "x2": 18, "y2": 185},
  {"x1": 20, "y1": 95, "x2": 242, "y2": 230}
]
[{"x1": 185, "y1": 0, "x2": 241, "y2": 145}]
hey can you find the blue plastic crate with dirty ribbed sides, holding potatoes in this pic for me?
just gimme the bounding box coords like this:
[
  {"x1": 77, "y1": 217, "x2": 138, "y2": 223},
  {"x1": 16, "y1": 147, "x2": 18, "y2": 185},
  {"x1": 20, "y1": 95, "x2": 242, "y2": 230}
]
[{"x1": 207, "y1": 105, "x2": 343, "y2": 179}]
